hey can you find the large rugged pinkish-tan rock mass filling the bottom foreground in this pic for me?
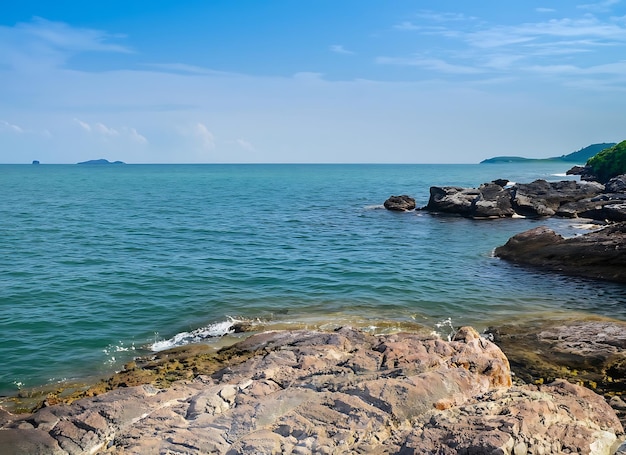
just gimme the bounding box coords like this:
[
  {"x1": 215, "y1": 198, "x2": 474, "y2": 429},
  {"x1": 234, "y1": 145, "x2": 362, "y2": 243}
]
[{"x1": 0, "y1": 328, "x2": 623, "y2": 454}]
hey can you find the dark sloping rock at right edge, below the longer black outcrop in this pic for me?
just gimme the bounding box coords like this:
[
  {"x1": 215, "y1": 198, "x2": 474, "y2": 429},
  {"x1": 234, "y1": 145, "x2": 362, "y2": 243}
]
[{"x1": 495, "y1": 222, "x2": 626, "y2": 283}]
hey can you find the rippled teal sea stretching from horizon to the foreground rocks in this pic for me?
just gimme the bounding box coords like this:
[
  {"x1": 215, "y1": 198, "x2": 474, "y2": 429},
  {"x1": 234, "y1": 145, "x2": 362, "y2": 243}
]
[{"x1": 0, "y1": 163, "x2": 626, "y2": 395}]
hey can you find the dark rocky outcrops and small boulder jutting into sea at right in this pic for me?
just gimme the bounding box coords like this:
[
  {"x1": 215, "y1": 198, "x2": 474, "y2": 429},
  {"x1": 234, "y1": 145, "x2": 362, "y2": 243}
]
[{"x1": 384, "y1": 174, "x2": 626, "y2": 283}]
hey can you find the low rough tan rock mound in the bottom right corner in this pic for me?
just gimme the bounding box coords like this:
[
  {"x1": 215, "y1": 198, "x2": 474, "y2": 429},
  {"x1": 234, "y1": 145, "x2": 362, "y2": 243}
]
[{"x1": 400, "y1": 381, "x2": 616, "y2": 455}]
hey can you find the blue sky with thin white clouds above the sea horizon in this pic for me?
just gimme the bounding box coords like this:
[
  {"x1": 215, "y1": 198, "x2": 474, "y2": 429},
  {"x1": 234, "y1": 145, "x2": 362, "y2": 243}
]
[{"x1": 0, "y1": 0, "x2": 626, "y2": 163}]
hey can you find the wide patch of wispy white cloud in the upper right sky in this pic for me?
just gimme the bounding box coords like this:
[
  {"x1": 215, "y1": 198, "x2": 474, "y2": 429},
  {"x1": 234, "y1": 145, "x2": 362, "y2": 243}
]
[{"x1": 375, "y1": 5, "x2": 626, "y2": 88}]
